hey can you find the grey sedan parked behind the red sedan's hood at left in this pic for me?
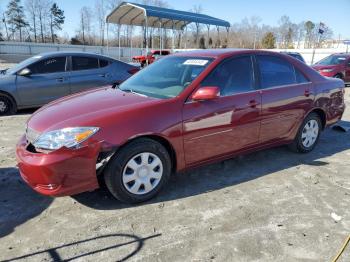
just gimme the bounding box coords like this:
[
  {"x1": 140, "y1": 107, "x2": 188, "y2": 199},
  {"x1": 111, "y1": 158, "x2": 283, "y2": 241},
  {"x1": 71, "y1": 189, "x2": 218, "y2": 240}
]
[{"x1": 0, "y1": 52, "x2": 138, "y2": 115}]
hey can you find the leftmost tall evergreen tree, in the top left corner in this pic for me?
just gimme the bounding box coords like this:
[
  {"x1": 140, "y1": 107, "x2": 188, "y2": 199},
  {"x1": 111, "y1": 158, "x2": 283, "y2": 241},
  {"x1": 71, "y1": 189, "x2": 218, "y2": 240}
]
[{"x1": 6, "y1": 0, "x2": 28, "y2": 41}]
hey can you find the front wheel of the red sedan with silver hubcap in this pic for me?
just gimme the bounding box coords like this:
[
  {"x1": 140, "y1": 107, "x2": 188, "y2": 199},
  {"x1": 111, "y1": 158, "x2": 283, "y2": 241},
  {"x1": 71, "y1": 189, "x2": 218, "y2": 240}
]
[{"x1": 104, "y1": 138, "x2": 171, "y2": 204}]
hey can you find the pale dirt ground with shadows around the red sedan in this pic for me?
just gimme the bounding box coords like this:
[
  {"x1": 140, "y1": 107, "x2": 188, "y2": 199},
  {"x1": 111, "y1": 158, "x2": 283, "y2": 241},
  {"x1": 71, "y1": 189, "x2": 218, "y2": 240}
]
[{"x1": 0, "y1": 90, "x2": 350, "y2": 261}]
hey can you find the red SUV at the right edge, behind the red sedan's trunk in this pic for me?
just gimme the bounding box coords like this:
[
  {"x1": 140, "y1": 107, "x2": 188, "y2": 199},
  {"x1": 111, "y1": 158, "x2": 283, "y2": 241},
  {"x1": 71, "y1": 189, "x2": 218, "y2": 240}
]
[{"x1": 312, "y1": 53, "x2": 350, "y2": 83}]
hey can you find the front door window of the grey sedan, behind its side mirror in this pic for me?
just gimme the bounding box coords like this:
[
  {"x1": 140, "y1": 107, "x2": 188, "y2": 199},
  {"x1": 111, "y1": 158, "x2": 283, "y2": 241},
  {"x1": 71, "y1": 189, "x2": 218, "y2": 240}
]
[{"x1": 28, "y1": 56, "x2": 66, "y2": 74}]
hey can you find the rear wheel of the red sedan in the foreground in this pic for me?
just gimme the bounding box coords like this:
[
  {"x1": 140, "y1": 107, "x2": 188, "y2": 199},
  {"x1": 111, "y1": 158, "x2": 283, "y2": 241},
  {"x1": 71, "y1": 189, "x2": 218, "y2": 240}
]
[{"x1": 289, "y1": 113, "x2": 322, "y2": 153}]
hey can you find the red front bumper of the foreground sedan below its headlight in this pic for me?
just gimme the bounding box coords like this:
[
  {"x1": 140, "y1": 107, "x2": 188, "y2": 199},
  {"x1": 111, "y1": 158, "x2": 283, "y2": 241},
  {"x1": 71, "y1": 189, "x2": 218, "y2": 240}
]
[{"x1": 16, "y1": 136, "x2": 101, "y2": 196}]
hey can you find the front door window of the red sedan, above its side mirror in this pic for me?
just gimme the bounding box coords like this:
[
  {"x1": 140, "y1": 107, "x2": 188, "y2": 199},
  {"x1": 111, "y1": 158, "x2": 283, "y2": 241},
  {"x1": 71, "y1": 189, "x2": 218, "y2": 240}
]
[{"x1": 201, "y1": 56, "x2": 254, "y2": 96}]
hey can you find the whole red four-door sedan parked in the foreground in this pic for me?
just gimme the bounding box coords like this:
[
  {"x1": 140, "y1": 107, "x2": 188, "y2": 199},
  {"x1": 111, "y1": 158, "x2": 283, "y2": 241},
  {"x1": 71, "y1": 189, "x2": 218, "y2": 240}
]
[{"x1": 16, "y1": 49, "x2": 345, "y2": 203}]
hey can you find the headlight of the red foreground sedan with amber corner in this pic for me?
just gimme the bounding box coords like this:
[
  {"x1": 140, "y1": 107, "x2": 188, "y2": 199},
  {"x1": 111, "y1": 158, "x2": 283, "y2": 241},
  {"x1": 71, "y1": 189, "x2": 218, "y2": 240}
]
[{"x1": 33, "y1": 127, "x2": 99, "y2": 150}]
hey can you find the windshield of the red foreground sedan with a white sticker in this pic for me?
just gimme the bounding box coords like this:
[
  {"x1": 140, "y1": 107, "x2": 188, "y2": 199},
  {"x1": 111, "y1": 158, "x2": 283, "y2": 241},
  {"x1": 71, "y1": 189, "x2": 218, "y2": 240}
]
[{"x1": 119, "y1": 56, "x2": 213, "y2": 99}]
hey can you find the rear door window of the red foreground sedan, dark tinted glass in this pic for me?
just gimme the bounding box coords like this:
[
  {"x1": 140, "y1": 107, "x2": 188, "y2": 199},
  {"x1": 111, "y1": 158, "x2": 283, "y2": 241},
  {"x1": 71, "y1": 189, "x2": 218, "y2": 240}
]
[{"x1": 257, "y1": 55, "x2": 297, "y2": 88}]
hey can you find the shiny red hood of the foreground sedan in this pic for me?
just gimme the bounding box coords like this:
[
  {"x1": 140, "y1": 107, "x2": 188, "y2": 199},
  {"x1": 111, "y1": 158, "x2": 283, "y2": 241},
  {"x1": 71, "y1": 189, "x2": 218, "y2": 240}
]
[{"x1": 27, "y1": 87, "x2": 160, "y2": 133}]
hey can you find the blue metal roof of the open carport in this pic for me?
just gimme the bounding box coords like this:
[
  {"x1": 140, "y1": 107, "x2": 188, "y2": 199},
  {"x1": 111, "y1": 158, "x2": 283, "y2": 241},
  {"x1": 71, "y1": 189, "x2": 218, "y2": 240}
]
[{"x1": 106, "y1": 2, "x2": 230, "y2": 30}]
